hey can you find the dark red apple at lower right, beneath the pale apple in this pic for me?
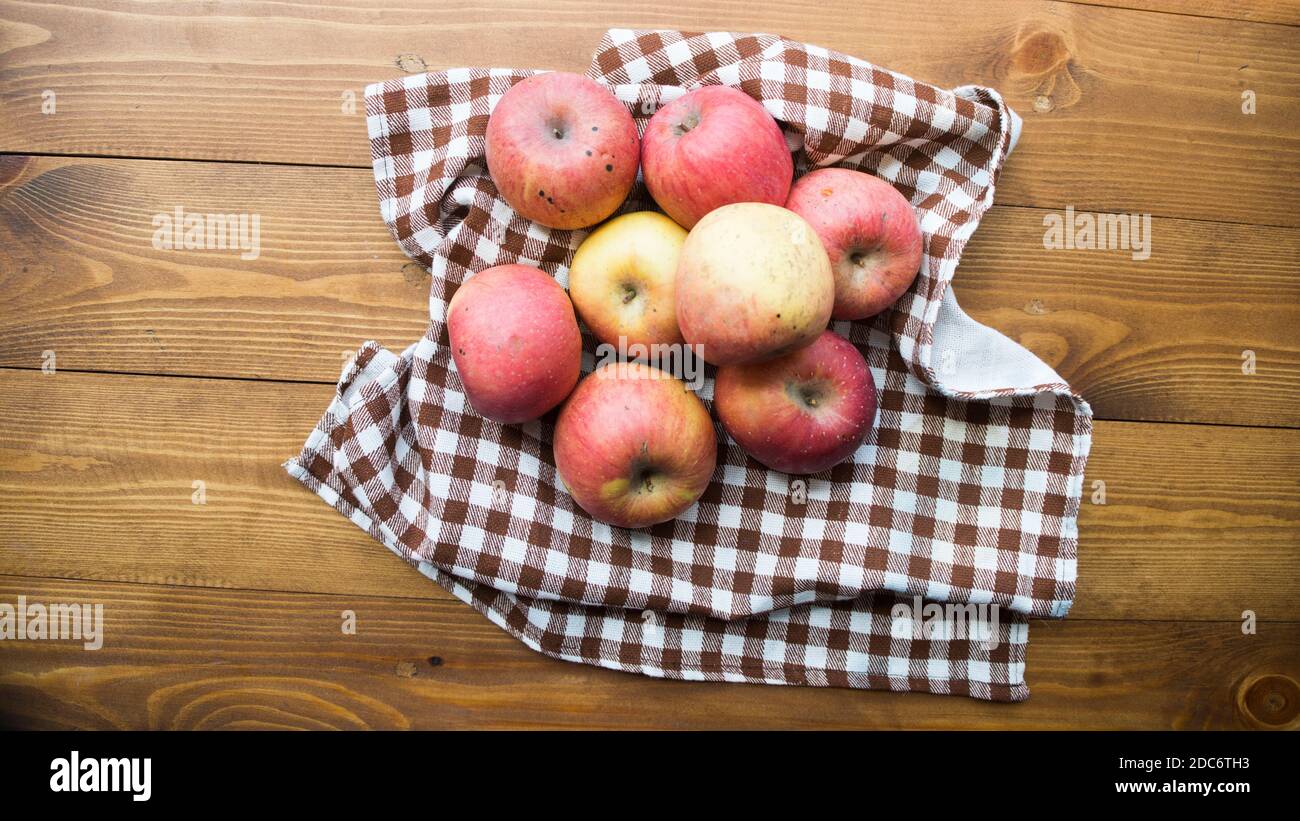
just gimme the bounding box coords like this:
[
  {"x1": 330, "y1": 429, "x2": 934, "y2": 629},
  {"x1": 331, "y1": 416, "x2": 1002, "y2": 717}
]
[{"x1": 714, "y1": 331, "x2": 876, "y2": 473}]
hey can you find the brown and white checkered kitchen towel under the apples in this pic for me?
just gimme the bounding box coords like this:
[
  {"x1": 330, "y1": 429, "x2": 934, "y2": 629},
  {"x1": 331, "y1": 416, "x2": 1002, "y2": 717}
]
[{"x1": 286, "y1": 30, "x2": 1091, "y2": 700}]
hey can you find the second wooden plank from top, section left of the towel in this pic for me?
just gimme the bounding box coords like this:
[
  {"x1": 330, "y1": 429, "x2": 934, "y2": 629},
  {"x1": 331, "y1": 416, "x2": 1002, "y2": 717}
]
[{"x1": 0, "y1": 157, "x2": 429, "y2": 382}]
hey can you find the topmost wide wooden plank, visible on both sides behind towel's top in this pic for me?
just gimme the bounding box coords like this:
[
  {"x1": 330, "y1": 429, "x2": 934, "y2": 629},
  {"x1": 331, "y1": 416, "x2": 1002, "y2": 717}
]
[{"x1": 0, "y1": 0, "x2": 1300, "y2": 226}]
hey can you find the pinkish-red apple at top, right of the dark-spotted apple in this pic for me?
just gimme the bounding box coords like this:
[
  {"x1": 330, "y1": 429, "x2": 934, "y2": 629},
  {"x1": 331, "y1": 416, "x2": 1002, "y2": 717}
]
[{"x1": 641, "y1": 86, "x2": 794, "y2": 229}]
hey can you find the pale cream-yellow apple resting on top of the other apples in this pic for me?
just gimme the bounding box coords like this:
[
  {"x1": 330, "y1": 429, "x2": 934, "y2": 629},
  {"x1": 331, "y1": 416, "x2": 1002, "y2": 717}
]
[{"x1": 677, "y1": 203, "x2": 835, "y2": 365}]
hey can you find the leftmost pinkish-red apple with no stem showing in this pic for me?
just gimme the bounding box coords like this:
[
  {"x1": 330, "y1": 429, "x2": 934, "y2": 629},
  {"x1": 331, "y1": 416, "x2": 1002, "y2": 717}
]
[{"x1": 447, "y1": 265, "x2": 582, "y2": 425}]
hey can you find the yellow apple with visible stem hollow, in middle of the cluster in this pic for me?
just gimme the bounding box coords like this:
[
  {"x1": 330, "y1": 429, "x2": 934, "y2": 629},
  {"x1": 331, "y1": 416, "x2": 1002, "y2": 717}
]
[{"x1": 569, "y1": 210, "x2": 686, "y2": 347}]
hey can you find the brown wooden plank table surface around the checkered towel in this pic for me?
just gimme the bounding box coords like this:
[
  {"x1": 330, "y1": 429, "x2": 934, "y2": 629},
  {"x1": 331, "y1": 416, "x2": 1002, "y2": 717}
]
[{"x1": 0, "y1": 0, "x2": 1300, "y2": 727}]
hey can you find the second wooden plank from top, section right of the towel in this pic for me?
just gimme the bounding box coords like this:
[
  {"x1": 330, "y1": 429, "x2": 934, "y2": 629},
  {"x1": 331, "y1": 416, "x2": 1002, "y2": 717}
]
[{"x1": 953, "y1": 208, "x2": 1300, "y2": 427}]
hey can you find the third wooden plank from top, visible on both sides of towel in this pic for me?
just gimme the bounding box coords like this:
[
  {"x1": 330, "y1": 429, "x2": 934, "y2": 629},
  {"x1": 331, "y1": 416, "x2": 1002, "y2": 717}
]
[{"x1": 0, "y1": 370, "x2": 1300, "y2": 621}]
